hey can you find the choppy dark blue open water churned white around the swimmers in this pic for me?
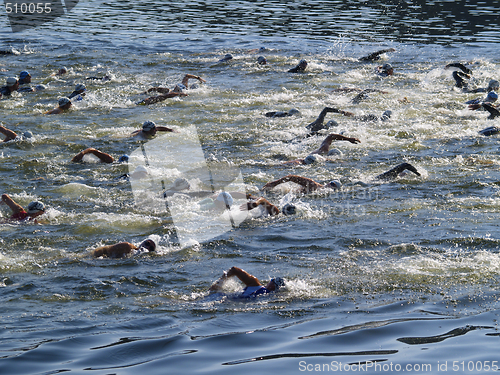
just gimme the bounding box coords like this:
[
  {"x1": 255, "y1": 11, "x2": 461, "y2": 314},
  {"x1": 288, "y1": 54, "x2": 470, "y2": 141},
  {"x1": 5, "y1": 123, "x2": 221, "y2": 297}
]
[{"x1": 0, "y1": 1, "x2": 500, "y2": 374}]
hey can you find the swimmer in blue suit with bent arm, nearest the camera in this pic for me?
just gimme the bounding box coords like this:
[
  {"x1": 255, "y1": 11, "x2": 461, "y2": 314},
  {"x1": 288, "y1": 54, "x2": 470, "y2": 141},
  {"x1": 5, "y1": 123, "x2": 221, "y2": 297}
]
[{"x1": 209, "y1": 267, "x2": 286, "y2": 298}]
